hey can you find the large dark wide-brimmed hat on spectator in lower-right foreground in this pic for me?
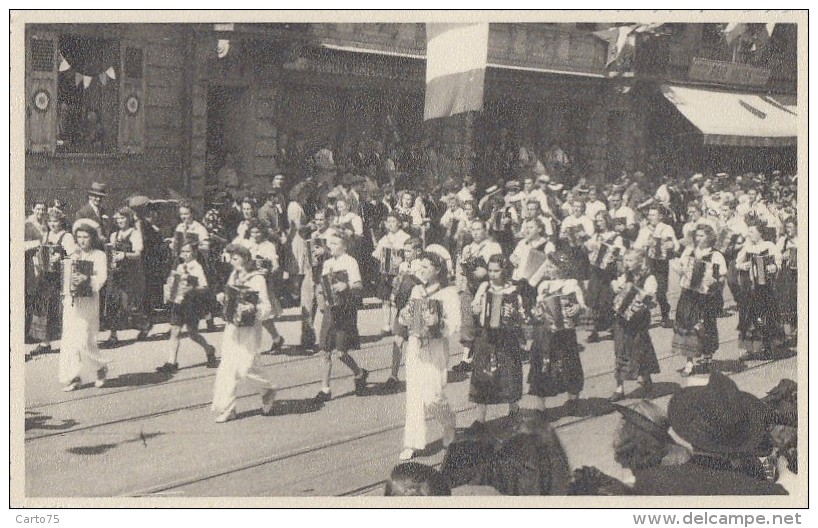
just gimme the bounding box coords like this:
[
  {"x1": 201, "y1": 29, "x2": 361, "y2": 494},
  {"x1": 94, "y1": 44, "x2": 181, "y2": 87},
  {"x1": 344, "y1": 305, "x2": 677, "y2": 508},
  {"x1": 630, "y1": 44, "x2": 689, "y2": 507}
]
[{"x1": 667, "y1": 372, "x2": 766, "y2": 453}]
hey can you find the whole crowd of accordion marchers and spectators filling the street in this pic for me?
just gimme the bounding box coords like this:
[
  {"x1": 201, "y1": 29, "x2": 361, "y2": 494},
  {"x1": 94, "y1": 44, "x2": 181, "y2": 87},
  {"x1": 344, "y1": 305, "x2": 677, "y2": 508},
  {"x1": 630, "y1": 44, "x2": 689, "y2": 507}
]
[{"x1": 20, "y1": 143, "x2": 799, "y2": 495}]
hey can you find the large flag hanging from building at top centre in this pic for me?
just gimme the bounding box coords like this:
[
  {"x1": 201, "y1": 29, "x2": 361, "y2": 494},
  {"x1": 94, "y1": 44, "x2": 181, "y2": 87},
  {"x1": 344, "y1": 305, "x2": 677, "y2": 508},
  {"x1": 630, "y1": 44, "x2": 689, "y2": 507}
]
[{"x1": 423, "y1": 23, "x2": 489, "y2": 120}]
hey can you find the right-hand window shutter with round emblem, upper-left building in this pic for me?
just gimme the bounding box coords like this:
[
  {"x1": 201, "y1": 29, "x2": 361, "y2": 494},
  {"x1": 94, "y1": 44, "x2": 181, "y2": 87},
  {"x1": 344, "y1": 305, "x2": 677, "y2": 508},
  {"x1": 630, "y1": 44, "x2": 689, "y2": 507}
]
[{"x1": 118, "y1": 40, "x2": 146, "y2": 154}]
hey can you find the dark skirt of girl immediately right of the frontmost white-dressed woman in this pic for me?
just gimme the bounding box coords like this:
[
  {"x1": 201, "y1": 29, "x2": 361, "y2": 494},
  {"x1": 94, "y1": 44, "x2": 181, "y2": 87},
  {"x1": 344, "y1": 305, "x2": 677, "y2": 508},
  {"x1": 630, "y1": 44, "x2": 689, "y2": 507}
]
[{"x1": 469, "y1": 329, "x2": 523, "y2": 405}]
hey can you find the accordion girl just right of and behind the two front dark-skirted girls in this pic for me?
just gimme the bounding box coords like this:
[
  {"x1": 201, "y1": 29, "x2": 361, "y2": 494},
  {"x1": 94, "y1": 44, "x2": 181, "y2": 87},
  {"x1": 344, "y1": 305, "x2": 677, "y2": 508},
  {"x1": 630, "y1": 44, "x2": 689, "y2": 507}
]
[{"x1": 585, "y1": 210, "x2": 625, "y2": 343}]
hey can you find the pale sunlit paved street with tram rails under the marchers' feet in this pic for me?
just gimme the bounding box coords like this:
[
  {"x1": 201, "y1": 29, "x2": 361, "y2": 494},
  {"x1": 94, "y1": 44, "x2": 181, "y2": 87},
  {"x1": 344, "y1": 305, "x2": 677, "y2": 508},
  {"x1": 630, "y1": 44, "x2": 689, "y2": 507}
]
[{"x1": 25, "y1": 280, "x2": 796, "y2": 497}]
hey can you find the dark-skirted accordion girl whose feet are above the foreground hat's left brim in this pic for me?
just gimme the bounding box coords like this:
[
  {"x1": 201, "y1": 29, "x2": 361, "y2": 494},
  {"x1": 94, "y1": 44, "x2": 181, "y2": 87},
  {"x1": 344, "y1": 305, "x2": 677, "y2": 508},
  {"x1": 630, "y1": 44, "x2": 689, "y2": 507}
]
[{"x1": 673, "y1": 224, "x2": 727, "y2": 377}]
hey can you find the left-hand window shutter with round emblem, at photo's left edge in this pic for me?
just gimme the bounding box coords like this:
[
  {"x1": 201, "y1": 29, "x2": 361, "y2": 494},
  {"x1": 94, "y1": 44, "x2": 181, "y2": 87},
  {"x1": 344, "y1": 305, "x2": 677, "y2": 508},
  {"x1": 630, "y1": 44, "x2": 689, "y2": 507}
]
[{"x1": 26, "y1": 32, "x2": 59, "y2": 153}]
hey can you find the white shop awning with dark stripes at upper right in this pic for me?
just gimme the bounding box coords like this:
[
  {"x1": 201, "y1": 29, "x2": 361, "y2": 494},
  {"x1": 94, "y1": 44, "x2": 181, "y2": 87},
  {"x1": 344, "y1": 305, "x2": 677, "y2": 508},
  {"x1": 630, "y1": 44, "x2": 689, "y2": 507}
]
[{"x1": 662, "y1": 85, "x2": 798, "y2": 147}]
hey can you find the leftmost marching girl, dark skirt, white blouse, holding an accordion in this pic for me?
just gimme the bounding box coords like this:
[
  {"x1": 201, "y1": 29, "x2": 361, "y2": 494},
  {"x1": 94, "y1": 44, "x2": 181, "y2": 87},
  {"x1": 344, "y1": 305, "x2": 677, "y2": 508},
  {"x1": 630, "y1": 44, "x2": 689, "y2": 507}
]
[{"x1": 30, "y1": 208, "x2": 77, "y2": 356}]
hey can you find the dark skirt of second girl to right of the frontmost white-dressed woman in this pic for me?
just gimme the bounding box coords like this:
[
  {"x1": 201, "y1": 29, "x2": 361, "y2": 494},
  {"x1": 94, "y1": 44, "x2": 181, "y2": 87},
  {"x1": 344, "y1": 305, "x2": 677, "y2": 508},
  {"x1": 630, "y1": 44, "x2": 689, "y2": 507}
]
[{"x1": 528, "y1": 325, "x2": 585, "y2": 397}]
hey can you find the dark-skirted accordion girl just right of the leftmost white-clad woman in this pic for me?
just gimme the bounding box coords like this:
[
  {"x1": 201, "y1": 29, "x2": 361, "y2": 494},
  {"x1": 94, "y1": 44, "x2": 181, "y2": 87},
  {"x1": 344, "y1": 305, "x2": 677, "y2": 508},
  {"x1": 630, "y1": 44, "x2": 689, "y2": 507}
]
[{"x1": 105, "y1": 207, "x2": 149, "y2": 348}]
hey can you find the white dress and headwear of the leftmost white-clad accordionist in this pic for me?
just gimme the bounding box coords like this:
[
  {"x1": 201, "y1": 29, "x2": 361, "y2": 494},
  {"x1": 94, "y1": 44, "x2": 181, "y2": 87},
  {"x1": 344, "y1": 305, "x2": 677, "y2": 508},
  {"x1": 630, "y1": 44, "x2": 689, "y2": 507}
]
[{"x1": 58, "y1": 249, "x2": 108, "y2": 385}]
